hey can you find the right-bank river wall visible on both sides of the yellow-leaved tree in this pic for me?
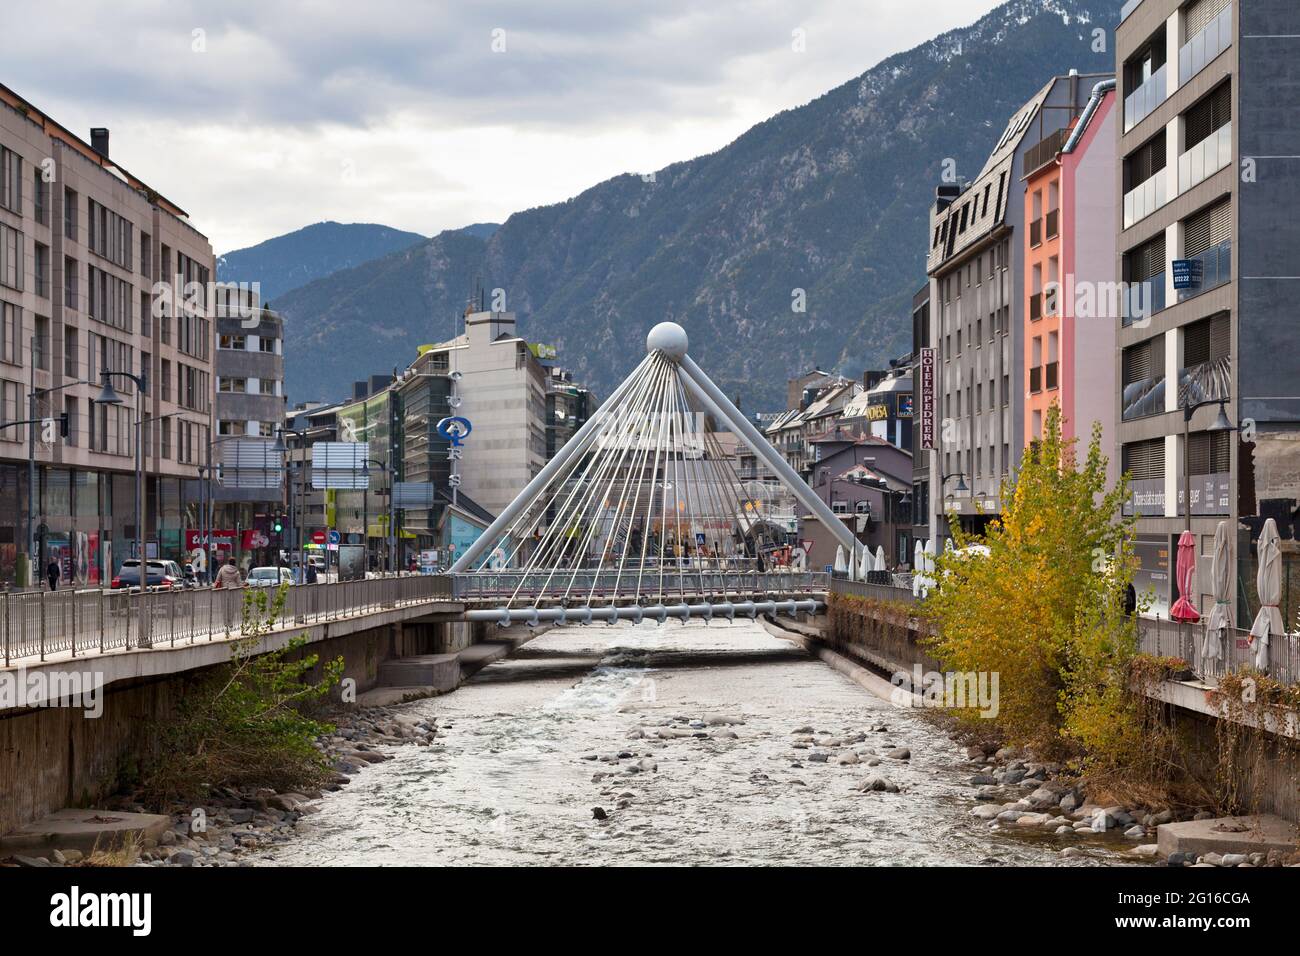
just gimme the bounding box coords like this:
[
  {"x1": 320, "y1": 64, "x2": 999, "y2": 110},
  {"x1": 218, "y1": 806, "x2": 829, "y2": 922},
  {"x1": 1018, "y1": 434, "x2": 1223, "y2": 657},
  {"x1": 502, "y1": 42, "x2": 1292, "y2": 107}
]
[{"x1": 780, "y1": 585, "x2": 1300, "y2": 822}]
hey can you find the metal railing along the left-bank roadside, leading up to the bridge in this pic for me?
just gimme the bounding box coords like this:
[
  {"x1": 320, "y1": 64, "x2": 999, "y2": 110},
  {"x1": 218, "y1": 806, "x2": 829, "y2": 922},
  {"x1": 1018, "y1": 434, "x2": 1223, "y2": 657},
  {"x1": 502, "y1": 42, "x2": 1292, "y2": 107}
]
[{"x1": 0, "y1": 575, "x2": 451, "y2": 667}]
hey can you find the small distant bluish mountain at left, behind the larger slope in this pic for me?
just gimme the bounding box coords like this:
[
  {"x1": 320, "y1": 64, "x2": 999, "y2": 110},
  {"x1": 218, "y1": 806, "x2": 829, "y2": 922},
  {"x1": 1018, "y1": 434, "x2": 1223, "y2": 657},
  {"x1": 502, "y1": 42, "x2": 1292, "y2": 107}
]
[{"x1": 217, "y1": 222, "x2": 425, "y2": 302}]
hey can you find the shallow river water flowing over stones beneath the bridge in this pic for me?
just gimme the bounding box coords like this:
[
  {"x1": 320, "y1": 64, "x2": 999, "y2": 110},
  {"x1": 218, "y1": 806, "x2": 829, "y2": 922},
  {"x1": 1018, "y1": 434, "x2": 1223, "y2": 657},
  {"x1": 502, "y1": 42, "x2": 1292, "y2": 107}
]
[{"x1": 252, "y1": 622, "x2": 1138, "y2": 865}]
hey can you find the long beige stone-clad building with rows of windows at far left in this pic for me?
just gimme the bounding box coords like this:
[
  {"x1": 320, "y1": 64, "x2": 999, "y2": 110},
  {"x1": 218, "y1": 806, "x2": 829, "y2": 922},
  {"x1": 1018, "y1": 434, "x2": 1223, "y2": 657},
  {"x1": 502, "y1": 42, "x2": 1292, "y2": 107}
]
[{"x1": 0, "y1": 86, "x2": 215, "y2": 584}]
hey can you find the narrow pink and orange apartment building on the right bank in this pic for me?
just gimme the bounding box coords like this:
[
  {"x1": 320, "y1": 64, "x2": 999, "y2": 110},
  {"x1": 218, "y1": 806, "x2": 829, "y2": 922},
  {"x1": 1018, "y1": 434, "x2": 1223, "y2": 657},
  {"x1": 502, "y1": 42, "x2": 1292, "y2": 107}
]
[{"x1": 1021, "y1": 77, "x2": 1123, "y2": 484}]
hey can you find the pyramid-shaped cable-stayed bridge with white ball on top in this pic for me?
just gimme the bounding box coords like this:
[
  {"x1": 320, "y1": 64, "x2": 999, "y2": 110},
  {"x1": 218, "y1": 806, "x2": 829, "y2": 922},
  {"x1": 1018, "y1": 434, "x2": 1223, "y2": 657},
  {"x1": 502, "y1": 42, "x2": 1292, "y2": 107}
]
[{"x1": 451, "y1": 323, "x2": 861, "y2": 627}]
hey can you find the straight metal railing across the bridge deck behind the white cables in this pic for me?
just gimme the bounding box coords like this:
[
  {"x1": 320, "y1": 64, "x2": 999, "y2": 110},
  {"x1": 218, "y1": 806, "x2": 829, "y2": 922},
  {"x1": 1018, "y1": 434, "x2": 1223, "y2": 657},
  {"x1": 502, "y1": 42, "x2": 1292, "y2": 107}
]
[{"x1": 451, "y1": 567, "x2": 829, "y2": 602}]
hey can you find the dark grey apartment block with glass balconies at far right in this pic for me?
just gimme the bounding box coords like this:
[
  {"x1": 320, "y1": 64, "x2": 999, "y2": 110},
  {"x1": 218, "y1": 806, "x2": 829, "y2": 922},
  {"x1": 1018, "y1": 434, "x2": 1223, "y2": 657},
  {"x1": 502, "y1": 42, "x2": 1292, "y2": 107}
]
[{"x1": 1115, "y1": 0, "x2": 1300, "y2": 623}]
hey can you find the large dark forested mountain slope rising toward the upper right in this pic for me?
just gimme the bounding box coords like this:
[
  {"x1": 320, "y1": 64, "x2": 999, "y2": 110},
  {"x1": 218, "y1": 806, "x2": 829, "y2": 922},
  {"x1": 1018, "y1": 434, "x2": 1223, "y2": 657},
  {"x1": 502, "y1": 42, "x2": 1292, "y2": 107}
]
[{"x1": 277, "y1": 0, "x2": 1118, "y2": 411}]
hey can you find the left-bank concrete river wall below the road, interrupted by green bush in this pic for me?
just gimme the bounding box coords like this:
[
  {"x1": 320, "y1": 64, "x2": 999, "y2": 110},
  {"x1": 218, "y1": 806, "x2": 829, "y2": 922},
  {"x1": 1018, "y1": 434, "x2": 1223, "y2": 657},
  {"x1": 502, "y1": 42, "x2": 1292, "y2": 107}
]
[{"x1": 0, "y1": 622, "x2": 501, "y2": 834}]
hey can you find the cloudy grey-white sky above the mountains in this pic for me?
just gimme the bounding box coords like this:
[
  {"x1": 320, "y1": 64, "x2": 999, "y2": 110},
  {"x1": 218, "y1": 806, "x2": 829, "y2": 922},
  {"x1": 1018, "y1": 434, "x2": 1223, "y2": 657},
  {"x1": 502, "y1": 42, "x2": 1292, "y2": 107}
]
[{"x1": 10, "y1": 0, "x2": 997, "y2": 254}]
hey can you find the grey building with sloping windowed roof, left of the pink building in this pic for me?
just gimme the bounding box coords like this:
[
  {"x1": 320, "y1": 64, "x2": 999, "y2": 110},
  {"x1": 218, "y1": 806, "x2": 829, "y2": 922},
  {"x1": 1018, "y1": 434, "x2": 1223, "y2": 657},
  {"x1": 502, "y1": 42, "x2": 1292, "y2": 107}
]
[{"x1": 922, "y1": 73, "x2": 1097, "y2": 540}]
